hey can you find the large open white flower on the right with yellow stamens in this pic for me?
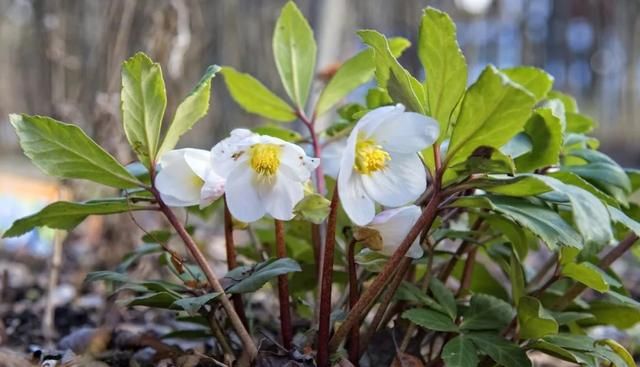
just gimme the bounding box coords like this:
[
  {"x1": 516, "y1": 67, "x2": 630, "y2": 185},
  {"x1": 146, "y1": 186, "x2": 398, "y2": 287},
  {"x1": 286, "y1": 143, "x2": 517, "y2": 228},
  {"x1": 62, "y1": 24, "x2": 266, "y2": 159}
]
[{"x1": 338, "y1": 104, "x2": 439, "y2": 226}]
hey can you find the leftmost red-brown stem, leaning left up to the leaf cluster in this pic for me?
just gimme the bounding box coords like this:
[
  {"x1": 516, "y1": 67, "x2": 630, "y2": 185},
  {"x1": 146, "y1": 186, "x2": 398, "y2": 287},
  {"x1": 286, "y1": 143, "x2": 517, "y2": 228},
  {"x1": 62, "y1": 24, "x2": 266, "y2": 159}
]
[{"x1": 151, "y1": 188, "x2": 258, "y2": 360}]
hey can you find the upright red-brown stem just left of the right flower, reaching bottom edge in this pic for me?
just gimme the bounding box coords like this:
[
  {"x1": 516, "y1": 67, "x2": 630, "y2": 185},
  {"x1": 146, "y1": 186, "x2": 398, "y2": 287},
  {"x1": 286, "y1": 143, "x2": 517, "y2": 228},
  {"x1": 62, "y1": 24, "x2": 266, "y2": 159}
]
[{"x1": 317, "y1": 187, "x2": 340, "y2": 367}]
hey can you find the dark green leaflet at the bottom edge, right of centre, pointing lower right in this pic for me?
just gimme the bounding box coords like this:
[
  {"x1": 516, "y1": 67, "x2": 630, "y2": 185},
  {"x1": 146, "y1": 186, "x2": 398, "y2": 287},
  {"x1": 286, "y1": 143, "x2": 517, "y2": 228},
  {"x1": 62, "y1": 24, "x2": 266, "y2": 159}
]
[{"x1": 467, "y1": 333, "x2": 531, "y2": 367}]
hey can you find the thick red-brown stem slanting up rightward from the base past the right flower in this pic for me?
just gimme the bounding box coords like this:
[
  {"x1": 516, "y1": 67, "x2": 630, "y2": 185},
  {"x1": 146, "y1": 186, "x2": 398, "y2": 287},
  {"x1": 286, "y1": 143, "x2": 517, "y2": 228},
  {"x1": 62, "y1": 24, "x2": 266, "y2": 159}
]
[{"x1": 329, "y1": 190, "x2": 442, "y2": 351}]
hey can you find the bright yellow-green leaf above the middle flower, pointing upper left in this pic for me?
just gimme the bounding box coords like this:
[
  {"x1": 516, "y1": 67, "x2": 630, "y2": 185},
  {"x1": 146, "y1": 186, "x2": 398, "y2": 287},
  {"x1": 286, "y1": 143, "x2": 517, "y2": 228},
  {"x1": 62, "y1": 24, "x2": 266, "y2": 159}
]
[{"x1": 221, "y1": 66, "x2": 296, "y2": 122}]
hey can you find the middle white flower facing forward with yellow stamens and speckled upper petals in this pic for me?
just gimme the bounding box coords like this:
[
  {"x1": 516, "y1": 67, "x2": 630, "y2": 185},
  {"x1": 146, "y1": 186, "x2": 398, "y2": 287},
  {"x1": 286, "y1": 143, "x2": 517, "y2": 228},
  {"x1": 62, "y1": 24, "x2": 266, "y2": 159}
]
[{"x1": 212, "y1": 129, "x2": 320, "y2": 222}]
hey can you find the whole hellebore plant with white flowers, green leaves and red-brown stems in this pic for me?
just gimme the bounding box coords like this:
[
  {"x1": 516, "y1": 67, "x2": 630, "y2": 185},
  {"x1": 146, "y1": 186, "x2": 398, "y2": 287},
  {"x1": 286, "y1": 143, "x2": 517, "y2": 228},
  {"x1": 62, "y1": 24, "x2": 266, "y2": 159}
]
[{"x1": 4, "y1": 2, "x2": 640, "y2": 367}]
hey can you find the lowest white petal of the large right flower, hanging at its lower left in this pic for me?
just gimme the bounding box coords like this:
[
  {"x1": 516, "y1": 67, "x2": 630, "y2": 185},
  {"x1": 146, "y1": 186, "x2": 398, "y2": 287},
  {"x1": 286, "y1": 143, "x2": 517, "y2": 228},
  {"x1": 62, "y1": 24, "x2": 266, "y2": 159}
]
[{"x1": 338, "y1": 173, "x2": 376, "y2": 226}]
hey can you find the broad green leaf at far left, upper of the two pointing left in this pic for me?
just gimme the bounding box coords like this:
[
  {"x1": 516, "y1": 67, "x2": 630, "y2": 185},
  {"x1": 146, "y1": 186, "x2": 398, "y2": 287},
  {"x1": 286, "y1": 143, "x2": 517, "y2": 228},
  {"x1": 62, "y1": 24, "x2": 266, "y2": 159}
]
[{"x1": 9, "y1": 114, "x2": 142, "y2": 189}]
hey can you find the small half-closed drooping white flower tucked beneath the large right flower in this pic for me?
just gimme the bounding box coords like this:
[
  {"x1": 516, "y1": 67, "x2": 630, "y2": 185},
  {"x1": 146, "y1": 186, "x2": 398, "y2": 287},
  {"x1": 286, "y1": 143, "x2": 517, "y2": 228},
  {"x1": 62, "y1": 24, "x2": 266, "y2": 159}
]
[{"x1": 354, "y1": 205, "x2": 424, "y2": 259}]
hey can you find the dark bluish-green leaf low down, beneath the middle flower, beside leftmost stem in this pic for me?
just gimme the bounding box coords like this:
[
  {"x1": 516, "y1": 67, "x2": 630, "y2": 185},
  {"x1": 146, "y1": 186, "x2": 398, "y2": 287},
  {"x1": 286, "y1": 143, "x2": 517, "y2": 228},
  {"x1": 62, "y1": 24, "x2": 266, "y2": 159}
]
[{"x1": 225, "y1": 258, "x2": 302, "y2": 293}]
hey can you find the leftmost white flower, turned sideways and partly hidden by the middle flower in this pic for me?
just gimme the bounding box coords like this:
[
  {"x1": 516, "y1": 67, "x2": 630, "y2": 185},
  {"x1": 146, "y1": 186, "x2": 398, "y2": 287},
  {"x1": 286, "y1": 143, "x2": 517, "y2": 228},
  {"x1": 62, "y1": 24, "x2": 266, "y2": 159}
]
[{"x1": 155, "y1": 148, "x2": 225, "y2": 208}]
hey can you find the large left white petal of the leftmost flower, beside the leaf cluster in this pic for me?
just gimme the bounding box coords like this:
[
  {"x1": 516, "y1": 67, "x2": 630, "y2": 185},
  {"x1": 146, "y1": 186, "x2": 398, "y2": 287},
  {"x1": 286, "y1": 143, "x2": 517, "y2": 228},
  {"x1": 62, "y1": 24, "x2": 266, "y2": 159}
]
[{"x1": 155, "y1": 149, "x2": 202, "y2": 206}]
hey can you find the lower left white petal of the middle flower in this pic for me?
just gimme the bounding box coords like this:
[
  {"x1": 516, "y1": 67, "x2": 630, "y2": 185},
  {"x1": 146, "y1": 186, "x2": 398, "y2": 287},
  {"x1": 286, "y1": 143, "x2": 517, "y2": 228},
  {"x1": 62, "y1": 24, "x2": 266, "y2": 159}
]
[{"x1": 226, "y1": 164, "x2": 265, "y2": 223}]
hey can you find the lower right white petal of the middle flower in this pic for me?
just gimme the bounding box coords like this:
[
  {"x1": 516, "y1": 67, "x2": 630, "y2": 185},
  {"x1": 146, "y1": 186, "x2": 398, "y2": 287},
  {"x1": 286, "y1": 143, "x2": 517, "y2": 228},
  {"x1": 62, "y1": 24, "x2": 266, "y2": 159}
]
[{"x1": 258, "y1": 172, "x2": 304, "y2": 220}]
